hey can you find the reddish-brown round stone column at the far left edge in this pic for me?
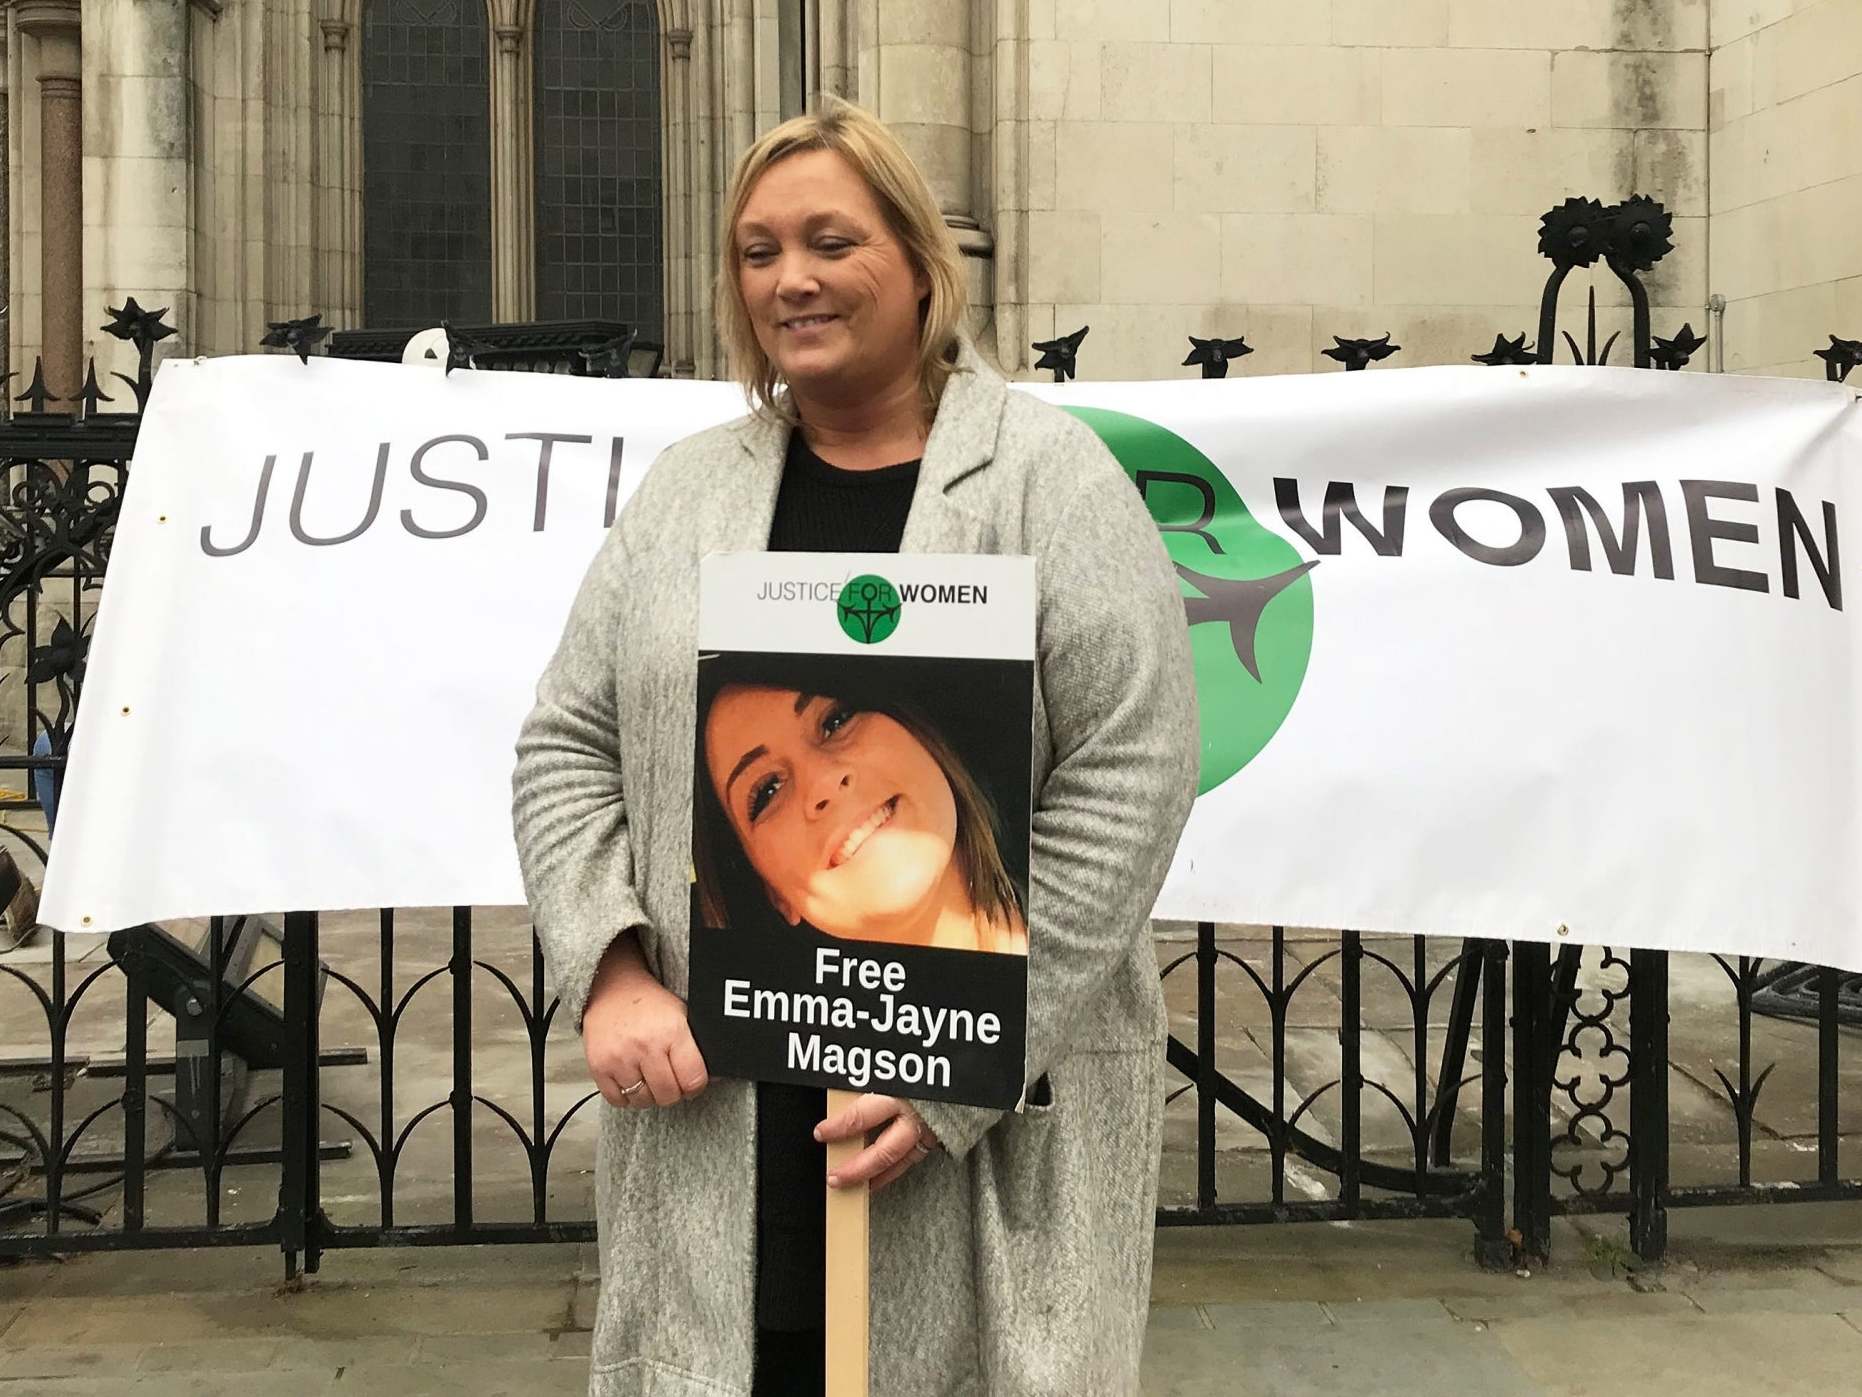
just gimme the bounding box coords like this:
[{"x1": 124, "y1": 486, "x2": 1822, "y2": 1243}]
[{"x1": 15, "y1": 0, "x2": 84, "y2": 397}]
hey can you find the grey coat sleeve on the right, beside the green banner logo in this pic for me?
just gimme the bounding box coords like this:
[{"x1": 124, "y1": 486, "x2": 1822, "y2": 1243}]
[{"x1": 912, "y1": 439, "x2": 1199, "y2": 1155}]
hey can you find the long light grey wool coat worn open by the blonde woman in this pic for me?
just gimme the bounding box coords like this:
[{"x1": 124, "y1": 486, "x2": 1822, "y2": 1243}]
[{"x1": 514, "y1": 345, "x2": 1197, "y2": 1397}]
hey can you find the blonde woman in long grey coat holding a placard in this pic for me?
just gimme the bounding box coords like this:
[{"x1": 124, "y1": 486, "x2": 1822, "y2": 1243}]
[{"x1": 514, "y1": 104, "x2": 1197, "y2": 1397}]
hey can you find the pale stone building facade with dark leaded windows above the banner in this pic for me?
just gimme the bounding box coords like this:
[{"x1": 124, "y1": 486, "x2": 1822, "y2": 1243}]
[{"x1": 4, "y1": 0, "x2": 1862, "y2": 393}]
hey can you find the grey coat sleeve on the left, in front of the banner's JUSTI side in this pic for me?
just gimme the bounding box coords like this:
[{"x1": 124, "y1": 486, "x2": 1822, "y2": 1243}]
[{"x1": 512, "y1": 523, "x2": 657, "y2": 1030}]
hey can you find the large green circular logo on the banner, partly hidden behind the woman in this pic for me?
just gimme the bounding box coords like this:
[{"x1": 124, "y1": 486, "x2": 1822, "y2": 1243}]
[{"x1": 1067, "y1": 408, "x2": 1316, "y2": 793}]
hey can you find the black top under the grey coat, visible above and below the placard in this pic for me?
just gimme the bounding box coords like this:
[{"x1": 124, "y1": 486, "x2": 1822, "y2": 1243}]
[{"x1": 756, "y1": 432, "x2": 918, "y2": 1330}]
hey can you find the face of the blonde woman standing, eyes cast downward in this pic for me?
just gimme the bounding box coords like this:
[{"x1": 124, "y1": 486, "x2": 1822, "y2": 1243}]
[{"x1": 734, "y1": 151, "x2": 929, "y2": 399}]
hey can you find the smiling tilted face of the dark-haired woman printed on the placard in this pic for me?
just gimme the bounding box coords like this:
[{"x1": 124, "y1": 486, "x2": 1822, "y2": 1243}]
[{"x1": 704, "y1": 684, "x2": 957, "y2": 939}]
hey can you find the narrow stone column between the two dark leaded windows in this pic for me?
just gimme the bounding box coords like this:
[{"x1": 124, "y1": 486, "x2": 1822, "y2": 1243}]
[{"x1": 488, "y1": 0, "x2": 536, "y2": 320}]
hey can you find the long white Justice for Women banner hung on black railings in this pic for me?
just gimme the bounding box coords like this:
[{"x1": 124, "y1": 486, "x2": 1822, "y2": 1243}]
[{"x1": 43, "y1": 358, "x2": 1862, "y2": 969}]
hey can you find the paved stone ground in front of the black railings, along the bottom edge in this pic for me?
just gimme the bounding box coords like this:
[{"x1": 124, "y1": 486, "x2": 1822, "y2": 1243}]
[{"x1": 0, "y1": 1207, "x2": 1862, "y2": 1397}]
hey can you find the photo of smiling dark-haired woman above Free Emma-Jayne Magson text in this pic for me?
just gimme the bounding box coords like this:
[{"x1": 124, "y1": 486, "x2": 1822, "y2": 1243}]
[{"x1": 693, "y1": 654, "x2": 1028, "y2": 956}]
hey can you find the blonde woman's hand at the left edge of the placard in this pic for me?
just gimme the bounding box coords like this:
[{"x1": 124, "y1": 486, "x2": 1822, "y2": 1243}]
[{"x1": 583, "y1": 931, "x2": 709, "y2": 1106}]
